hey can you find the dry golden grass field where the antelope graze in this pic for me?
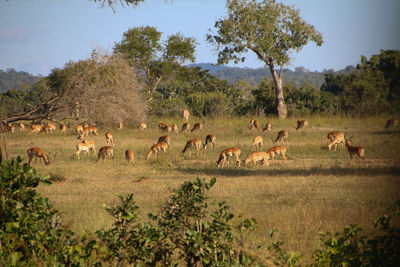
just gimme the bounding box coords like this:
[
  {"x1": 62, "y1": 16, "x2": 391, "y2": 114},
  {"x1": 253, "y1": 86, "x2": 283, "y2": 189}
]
[{"x1": 3, "y1": 117, "x2": 400, "y2": 261}]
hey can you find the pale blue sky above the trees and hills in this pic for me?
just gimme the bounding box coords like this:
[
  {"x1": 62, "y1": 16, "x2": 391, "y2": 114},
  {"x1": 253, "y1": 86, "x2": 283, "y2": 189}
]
[{"x1": 0, "y1": 0, "x2": 400, "y2": 75}]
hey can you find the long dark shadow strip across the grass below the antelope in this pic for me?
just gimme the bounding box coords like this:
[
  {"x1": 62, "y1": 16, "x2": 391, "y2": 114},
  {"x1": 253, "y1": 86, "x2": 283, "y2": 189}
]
[{"x1": 176, "y1": 166, "x2": 400, "y2": 177}]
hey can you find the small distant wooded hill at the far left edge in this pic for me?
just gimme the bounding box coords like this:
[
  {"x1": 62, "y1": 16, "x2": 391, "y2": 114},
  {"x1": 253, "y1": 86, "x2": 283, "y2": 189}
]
[{"x1": 0, "y1": 69, "x2": 43, "y2": 93}]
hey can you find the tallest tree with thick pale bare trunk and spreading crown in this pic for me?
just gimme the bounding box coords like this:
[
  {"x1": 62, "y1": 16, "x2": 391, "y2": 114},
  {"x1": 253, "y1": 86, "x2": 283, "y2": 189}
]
[{"x1": 207, "y1": 0, "x2": 323, "y2": 119}]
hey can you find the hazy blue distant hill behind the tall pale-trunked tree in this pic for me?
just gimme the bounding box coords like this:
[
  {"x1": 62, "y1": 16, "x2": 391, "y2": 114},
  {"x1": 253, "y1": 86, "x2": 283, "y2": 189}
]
[{"x1": 188, "y1": 63, "x2": 355, "y2": 88}]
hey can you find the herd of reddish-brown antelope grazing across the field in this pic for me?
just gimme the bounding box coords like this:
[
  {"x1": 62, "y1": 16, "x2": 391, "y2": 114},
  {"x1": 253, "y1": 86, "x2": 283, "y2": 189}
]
[{"x1": 4, "y1": 110, "x2": 398, "y2": 167}]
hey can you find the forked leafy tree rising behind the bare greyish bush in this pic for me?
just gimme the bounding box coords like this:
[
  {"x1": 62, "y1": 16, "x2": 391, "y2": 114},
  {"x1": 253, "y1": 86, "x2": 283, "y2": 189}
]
[{"x1": 114, "y1": 26, "x2": 196, "y2": 102}]
